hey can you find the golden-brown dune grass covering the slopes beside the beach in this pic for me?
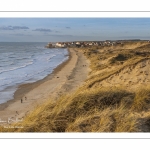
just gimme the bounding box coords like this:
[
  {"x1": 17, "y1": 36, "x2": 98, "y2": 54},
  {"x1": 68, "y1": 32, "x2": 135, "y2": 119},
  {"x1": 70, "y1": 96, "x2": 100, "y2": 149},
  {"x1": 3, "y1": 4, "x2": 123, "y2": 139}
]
[{"x1": 0, "y1": 41, "x2": 150, "y2": 132}]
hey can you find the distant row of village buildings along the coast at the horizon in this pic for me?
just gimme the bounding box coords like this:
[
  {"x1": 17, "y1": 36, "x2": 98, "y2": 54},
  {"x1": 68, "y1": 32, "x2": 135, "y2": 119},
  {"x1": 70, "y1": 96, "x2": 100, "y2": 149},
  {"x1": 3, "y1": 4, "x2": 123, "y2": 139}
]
[{"x1": 46, "y1": 41, "x2": 122, "y2": 48}]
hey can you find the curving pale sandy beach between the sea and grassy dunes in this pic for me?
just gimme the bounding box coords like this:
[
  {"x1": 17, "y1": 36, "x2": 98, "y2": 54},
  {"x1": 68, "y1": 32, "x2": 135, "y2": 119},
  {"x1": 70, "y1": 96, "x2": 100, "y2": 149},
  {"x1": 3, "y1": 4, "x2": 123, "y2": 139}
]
[{"x1": 0, "y1": 49, "x2": 89, "y2": 122}]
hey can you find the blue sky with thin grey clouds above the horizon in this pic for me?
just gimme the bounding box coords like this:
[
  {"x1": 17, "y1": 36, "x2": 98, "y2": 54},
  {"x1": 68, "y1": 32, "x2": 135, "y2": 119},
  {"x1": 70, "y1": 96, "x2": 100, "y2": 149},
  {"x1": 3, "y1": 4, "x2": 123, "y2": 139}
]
[{"x1": 0, "y1": 18, "x2": 150, "y2": 42}]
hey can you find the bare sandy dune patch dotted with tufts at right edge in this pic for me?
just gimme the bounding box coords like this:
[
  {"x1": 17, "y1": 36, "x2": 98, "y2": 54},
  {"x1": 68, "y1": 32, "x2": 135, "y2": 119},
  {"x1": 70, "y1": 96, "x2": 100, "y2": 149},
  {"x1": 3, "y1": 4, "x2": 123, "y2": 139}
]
[{"x1": 97, "y1": 59, "x2": 150, "y2": 90}]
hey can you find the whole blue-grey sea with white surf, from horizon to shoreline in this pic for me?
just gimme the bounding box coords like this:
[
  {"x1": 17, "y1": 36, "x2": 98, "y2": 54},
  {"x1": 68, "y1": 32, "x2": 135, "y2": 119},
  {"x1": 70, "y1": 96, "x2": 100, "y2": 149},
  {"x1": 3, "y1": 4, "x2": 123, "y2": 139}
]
[{"x1": 0, "y1": 42, "x2": 68, "y2": 104}]
